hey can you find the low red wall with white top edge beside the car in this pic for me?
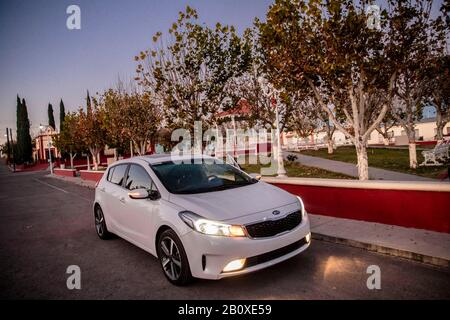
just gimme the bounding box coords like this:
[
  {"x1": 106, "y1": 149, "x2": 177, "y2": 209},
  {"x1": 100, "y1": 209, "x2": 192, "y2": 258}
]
[{"x1": 264, "y1": 178, "x2": 450, "y2": 233}]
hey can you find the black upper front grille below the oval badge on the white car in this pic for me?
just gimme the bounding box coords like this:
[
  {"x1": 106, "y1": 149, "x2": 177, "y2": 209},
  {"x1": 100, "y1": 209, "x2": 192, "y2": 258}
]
[{"x1": 245, "y1": 211, "x2": 302, "y2": 238}]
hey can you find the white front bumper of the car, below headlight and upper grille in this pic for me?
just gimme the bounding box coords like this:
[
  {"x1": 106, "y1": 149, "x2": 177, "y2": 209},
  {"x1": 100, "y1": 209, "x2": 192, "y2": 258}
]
[{"x1": 181, "y1": 218, "x2": 310, "y2": 279}]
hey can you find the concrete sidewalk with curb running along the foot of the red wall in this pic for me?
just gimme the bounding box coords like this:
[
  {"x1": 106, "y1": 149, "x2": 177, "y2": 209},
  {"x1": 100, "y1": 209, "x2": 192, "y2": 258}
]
[{"x1": 309, "y1": 214, "x2": 450, "y2": 268}]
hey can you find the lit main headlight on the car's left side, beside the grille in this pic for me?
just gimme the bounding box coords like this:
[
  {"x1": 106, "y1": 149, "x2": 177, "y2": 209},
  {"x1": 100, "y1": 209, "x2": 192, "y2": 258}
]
[{"x1": 179, "y1": 211, "x2": 246, "y2": 237}]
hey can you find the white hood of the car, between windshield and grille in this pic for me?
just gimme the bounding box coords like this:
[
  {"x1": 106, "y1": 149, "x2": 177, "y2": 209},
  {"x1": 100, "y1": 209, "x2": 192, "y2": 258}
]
[{"x1": 169, "y1": 181, "x2": 297, "y2": 221}]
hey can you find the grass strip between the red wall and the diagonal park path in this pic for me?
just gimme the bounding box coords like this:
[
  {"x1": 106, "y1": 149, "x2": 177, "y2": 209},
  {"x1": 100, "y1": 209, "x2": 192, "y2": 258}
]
[{"x1": 241, "y1": 161, "x2": 355, "y2": 179}]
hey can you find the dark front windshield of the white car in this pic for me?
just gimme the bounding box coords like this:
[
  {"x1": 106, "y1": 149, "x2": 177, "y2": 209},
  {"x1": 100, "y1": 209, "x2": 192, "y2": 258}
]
[{"x1": 151, "y1": 159, "x2": 257, "y2": 194}]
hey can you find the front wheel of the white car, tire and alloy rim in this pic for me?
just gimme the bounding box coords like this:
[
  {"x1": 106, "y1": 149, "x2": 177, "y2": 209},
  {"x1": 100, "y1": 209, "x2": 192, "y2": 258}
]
[{"x1": 157, "y1": 229, "x2": 193, "y2": 286}]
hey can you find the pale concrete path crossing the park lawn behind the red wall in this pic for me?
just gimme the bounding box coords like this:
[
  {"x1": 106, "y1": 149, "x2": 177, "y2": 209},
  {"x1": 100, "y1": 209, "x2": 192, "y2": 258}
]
[{"x1": 284, "y1": 152, "x2": 438, "y2": 181}]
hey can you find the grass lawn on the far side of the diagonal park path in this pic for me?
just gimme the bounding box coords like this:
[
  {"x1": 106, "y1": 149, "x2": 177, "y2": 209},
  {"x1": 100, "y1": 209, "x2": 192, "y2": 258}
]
[{"x1": 300, "y1": 146, "x2": 447, "y2": 179}]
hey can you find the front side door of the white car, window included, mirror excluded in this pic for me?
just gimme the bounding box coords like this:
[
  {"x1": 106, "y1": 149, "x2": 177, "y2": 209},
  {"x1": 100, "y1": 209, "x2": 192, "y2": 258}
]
[{"x1": 119, "y1": 163, "x2": 159, "y2": 250}]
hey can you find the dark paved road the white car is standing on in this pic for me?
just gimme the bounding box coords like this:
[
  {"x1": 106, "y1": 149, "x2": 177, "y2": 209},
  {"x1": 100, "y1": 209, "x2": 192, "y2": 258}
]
[{"x1": 0, "y1": 166, "x2": 450, "y2": 299}]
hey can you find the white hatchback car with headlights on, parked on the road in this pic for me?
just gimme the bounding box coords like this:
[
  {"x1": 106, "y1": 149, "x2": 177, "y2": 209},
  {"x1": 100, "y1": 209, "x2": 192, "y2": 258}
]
[{"x1": 93, "y1": 154, "x2": 311, "y2": 285}]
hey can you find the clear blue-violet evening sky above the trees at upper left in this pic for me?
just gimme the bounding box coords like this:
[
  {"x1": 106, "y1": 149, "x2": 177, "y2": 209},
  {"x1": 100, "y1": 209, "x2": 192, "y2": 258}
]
[{"x1": 0, "y1": 0, "x2": 272, "y2": 143}]
